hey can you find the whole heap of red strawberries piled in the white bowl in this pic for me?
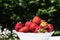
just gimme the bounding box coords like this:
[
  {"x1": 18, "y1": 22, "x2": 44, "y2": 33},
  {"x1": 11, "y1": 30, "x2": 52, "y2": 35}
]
[{"x1": 15, "y1": 16, "x2": 53, "y2": 33}]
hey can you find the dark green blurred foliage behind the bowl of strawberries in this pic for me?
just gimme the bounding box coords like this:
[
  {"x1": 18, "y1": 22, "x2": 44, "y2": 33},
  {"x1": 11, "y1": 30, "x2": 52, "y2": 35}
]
[{"x1": 0, "y1": 0, "x2": 60, "y2": 36}]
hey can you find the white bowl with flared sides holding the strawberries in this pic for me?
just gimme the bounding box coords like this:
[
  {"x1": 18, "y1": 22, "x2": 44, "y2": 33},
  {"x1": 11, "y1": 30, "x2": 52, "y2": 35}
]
[{"x1": 16, "y1": 31, "x2": 54, "y2": 40}]
